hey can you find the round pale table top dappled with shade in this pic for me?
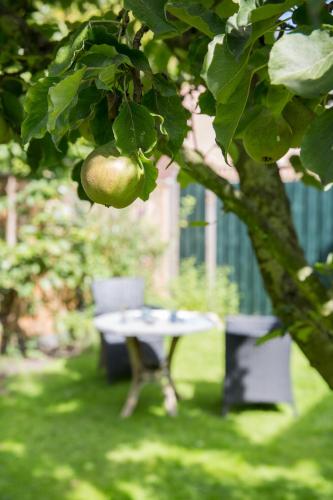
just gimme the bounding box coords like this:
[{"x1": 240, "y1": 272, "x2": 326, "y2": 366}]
[{"x1": 94, "y1": 308, "x2": 220, "y2": 337}]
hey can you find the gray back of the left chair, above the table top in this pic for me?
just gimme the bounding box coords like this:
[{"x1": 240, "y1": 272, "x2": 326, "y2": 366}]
[{"x1": 92, "y1": 278, "x2": 144, "y2": 315}]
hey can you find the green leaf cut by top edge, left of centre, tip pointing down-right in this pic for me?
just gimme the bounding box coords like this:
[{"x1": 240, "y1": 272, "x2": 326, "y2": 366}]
[{"x1": 124, "y1": 0, "x2": 176, "y2": 35}]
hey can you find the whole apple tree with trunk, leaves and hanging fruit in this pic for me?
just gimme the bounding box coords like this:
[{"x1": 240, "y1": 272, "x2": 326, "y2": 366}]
[{"x1": 0, "y1": 0, "x2": 333, "y2": 389}]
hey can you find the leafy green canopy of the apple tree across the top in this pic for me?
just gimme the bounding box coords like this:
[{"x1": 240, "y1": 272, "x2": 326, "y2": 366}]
[{"x1": 0, "y1": 0, "x2": 333, "y2": 199}]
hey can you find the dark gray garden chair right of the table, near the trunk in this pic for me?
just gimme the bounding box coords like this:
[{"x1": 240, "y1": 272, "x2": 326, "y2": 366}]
[{"x1": 222, "y1": 315, "x2": 296, "y2": 415}]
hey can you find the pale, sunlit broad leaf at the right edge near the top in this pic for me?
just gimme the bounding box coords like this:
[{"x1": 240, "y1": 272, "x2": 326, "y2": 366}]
[{"x1": 268, "y1": 30, "x2": 333, "y2": 98}]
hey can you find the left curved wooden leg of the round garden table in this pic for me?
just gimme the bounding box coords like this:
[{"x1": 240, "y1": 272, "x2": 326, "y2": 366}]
[{"x1": 121, "y1": 337, "x2": 144, "y2": 418}]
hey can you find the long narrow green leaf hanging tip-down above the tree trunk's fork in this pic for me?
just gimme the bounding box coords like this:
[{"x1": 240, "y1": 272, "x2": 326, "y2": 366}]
[{"x1": 214, "y1": 70, "x2": 253, "y2": 155}]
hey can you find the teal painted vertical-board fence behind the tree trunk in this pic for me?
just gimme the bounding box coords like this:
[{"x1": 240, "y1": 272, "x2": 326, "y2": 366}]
[{"x1": 180, "y1": 182, "x2": 333, "y2": 314}]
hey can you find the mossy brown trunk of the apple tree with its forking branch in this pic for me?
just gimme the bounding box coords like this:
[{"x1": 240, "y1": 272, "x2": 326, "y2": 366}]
[{"x1": 185, "y1": 146, "x2": 333, "y2": 390}]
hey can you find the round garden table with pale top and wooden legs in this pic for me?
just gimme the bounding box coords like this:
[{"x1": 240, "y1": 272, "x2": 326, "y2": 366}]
[{"x1": 94, "y1": 308, "x2": 219, "y2": 417}]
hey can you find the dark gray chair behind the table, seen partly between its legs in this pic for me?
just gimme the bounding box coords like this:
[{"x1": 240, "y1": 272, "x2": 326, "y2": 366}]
[{"x1": 92, "y1": 278, "x2": 164, "y2": 382}]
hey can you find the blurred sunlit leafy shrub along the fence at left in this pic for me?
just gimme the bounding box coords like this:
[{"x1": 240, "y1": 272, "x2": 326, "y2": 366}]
[{"x1": 0, "y1": 179, "x2": 163, "y2": 348}]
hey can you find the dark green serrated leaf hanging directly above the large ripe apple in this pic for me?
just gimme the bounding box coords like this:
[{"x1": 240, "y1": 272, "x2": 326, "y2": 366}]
[{"x1": 113, "y1": 102, "x2": 157, "y2": 155}]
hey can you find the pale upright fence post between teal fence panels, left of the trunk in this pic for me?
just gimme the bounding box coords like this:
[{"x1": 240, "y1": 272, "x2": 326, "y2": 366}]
[{"x1": 205, "y1": 190, "x2": 217, "y2": 288}]
